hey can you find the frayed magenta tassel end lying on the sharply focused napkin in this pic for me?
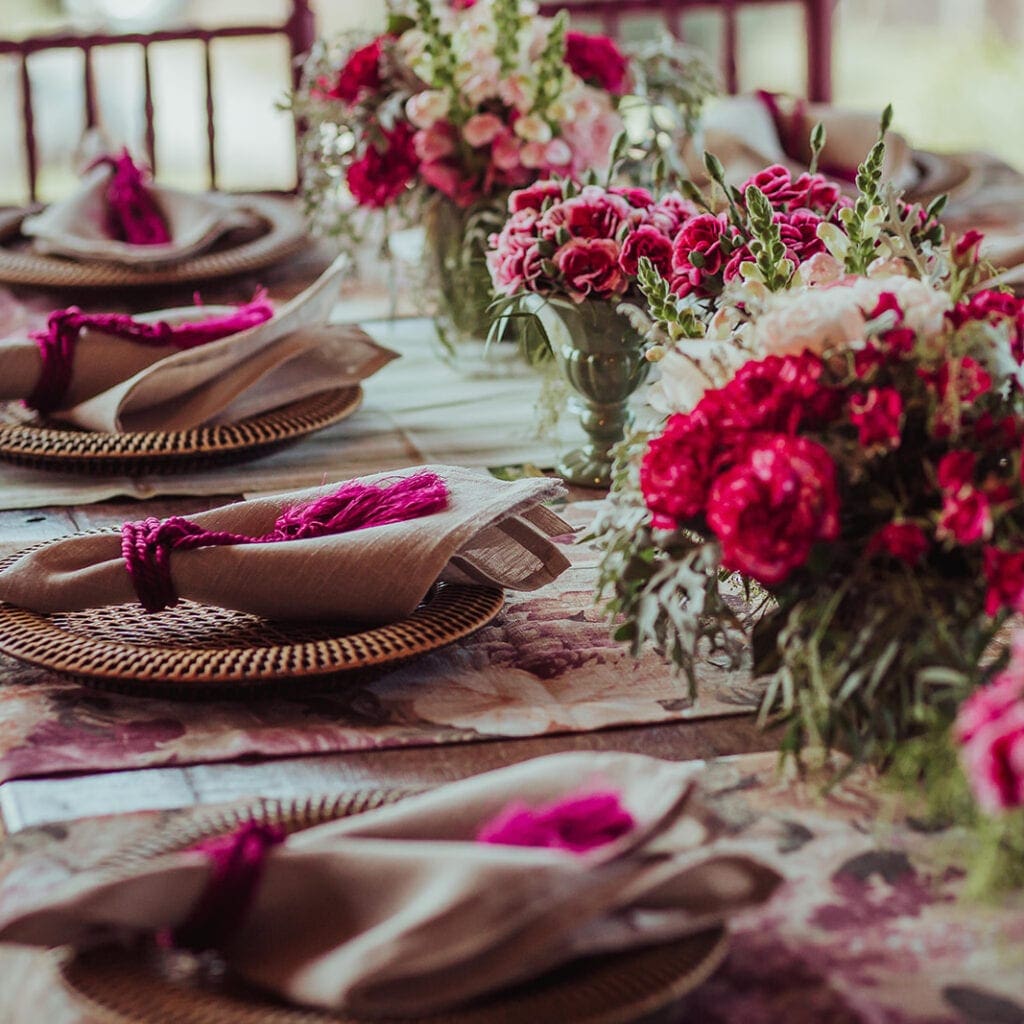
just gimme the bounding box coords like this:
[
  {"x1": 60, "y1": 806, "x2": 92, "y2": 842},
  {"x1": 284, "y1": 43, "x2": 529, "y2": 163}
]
[{"x1": 274, "y1": 473, "x2": 447, "y2": 541}]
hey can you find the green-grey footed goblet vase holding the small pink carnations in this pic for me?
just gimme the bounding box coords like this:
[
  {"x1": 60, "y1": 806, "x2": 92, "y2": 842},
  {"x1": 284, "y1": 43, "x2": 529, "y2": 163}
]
[{"x1": 531, "y1": 300, "x2": 650, "y2": 487}]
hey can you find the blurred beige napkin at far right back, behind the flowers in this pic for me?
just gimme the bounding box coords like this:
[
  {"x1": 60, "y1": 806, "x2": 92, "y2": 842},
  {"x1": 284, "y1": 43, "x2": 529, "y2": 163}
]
[{"x1": 684, "y1": 95, "x2": 920, "y2": 188}]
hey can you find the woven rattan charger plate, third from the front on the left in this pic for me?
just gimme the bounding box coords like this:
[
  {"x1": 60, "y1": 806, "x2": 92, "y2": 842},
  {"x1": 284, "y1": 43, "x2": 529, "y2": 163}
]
[{"x1": 0, "y1": 385, "x2": 362, "y2": 476}]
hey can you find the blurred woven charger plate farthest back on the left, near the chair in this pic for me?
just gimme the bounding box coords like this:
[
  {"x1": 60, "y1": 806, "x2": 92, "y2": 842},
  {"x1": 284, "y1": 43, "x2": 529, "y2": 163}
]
[{"x1": 0, "y1": 196, "x2": 308, "y2": 288}]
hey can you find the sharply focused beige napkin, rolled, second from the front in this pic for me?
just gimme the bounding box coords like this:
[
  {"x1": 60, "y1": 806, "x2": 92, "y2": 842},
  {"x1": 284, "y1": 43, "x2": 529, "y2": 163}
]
[{"x1": 0, "y1": 466, "x2": 570, "y2": 623}]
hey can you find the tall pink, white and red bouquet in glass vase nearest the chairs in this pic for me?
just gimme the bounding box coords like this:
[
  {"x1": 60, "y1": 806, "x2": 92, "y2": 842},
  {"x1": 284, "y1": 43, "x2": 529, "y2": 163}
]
[{"x1": 296, "y1": 0, "x2": 714, "y2": 356}]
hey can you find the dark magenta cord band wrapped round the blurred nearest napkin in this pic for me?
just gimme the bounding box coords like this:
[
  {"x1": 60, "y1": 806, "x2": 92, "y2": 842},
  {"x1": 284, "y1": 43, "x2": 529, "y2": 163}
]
[{"x1": 157, "y1": 821, "x2": 285, "y2": 953}]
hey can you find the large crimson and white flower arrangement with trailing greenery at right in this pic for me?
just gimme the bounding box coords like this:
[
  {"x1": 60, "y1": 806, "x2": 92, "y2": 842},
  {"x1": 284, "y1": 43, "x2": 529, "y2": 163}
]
[{"x1": 595, "y1": 108, "x2": 1024, "y2": 878}]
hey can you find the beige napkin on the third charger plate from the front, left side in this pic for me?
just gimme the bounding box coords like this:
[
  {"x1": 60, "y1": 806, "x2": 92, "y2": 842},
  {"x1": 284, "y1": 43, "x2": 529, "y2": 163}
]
[{"x1": 0, "y1": 258, "x2": 396, "y2": 431}]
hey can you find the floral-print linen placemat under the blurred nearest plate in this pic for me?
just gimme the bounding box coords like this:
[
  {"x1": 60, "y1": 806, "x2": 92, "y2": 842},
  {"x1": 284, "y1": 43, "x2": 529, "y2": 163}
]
[{"x1": 0, "y1": 753, "x2": 1024, "y2": 1024}]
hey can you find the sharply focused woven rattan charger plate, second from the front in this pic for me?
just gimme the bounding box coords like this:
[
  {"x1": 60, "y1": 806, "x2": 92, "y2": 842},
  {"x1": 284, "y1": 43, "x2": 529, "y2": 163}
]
[{"x1": 0, "y1": 531, "x2": 505, "y2": 698}]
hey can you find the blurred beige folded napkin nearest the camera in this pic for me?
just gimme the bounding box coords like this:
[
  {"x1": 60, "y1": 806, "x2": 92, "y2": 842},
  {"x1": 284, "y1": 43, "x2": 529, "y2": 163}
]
[{"x1": 0, "y1": 752, "x2": 781, "y2": 1017}]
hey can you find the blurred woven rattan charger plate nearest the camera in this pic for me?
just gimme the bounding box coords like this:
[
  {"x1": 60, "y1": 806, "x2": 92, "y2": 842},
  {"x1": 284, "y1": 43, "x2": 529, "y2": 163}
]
[{"x1": 61, "y1": 790, "x2": 728, "y2": 1024}]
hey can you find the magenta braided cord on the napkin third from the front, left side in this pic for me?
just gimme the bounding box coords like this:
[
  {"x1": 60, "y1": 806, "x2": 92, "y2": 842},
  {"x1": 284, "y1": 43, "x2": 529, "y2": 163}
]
[{"x1": 25, "y1": 288, "x2": 273, "y2": 413}]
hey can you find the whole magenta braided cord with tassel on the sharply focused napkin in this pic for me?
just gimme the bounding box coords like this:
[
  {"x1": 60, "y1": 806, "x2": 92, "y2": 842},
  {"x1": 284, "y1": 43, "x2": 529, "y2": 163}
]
[{"x1": 121, "y1": 472, "x2": 449, "y2": 612}]
